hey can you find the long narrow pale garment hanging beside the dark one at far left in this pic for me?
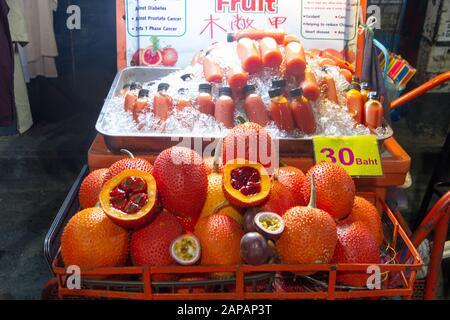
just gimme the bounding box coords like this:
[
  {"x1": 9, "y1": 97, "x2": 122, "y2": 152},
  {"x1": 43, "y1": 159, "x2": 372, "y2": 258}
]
[{"x1": 6, "y1": 0, "x2": 33, "y2": 133}]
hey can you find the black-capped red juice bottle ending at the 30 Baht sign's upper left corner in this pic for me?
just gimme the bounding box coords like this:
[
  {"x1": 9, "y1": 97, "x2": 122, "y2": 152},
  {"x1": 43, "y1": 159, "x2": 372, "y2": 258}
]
[{"x1": 289, "y1": 88, "x2": 317, "y2": 134}]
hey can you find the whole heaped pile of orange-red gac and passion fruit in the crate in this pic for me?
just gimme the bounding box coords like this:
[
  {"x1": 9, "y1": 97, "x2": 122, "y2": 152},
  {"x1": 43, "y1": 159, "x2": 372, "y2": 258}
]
[{"x1": 61, "y1": 123, "x2": 383, "y2": 286}]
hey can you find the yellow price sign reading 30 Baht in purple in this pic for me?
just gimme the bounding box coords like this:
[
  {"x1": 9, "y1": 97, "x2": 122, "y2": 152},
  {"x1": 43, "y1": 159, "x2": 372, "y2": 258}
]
[{"x1": 314, "y1": 136, "x2": 383, "y2": 176}]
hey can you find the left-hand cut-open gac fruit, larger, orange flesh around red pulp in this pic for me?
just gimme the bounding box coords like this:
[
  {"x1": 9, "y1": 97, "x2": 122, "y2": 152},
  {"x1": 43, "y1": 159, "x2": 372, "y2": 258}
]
[{"x1": 99, "y1": 170, "x2": 159, "y2": 229}]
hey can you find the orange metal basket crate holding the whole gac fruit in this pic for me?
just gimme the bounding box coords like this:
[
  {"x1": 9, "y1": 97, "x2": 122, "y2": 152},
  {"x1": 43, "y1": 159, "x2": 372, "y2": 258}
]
[{"x1": 44, "y1": 167, "x2": 422, "y2": 300}]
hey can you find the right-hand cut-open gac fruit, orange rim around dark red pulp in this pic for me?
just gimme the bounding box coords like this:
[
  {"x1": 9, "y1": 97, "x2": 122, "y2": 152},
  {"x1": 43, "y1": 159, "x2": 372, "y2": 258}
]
[{"x1": 223, "y1": 159, "x2": 270, "y2": 208}]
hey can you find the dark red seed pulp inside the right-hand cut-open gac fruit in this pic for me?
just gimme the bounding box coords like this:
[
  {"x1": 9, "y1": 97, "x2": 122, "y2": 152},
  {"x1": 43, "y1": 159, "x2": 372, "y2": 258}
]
[{"x1": 231, "y1": 167, "x2": 261, "y2": 196}]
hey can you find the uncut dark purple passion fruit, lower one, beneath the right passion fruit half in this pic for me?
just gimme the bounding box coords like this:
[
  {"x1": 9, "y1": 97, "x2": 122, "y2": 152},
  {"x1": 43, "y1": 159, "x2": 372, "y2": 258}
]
[{"x1": 241, "y1": 232, "x2": 272, "y2": 265}]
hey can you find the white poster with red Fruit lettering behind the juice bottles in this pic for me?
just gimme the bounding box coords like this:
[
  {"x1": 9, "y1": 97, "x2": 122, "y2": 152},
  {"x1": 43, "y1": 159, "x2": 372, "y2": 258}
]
[{"x1": 123, "y1": 0, "x2": 360, "y2": 67}]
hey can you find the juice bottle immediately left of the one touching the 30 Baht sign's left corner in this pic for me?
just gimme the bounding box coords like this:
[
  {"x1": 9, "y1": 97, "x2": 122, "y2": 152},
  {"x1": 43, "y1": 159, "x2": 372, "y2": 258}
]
[{"x1": 269, "y1": 88, "x2": 295, "y2": 131}]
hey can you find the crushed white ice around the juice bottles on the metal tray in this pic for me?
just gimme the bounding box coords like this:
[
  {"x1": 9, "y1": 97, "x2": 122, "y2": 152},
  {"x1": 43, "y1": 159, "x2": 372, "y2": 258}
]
[{"x1": 102, "y1": 43, "x2": 388, "y2": 138}]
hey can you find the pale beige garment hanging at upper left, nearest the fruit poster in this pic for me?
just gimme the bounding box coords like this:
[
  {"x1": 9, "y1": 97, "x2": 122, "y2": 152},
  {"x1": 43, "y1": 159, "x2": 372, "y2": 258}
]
[{"x1": 23, "y1": 0, "x2": 58, "y2": 79}]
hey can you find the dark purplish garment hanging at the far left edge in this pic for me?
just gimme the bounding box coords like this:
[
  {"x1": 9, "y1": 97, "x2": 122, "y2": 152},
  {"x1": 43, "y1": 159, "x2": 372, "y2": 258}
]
[{"x1": 0, "y1": 0, "x2": 15, "y2": 127}]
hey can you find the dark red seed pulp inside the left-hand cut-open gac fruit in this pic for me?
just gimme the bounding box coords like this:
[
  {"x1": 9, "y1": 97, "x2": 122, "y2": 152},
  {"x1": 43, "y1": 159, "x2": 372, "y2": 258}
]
[{"x1": 109, "y1": 177, "x2": 148, "y2": 214}]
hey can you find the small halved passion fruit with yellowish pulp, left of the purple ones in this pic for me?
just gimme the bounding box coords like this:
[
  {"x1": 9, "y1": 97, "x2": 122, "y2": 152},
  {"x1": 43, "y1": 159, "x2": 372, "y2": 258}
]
[{"x1": 170, "y1": 234, "x2": 201, "y2": 266}]
